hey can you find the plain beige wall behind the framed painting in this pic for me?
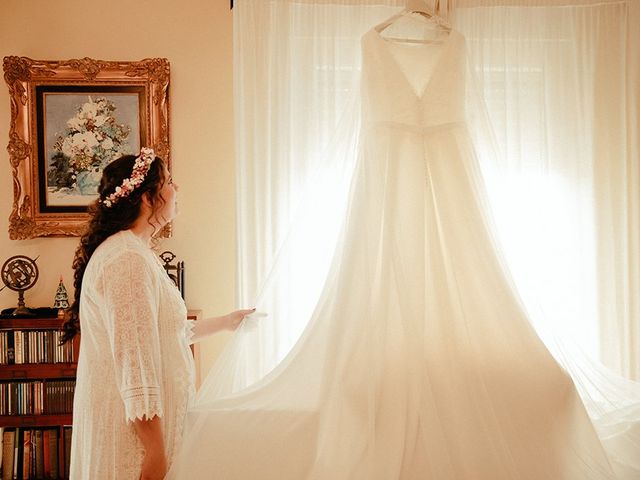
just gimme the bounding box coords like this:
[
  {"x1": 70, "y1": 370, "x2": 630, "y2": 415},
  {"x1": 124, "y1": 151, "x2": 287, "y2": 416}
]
[{"x1": 0, "y1": 0, "x2": 235, "y2": 378}]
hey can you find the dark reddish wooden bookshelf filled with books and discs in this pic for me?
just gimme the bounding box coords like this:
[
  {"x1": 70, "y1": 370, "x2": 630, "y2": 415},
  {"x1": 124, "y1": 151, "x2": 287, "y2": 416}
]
[{"x1": 0, "y1": 315, "x2": 80, "y2": 480}]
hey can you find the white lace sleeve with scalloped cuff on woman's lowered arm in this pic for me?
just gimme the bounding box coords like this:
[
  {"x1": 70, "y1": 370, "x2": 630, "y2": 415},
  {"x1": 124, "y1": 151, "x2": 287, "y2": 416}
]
[{"x1": 103, "y1": 251, "x2": 164, "y2": 421}]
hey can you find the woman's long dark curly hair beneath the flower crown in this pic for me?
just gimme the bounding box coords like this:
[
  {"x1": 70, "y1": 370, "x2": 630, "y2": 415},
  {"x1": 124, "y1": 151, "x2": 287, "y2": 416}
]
[{"x1": 60, "y1": 155, "x2": 166, "y2": 344}]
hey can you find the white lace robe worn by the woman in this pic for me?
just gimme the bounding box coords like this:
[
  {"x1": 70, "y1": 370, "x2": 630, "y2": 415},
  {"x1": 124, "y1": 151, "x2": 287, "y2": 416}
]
[{"x1": 71, "y1": 230, "x2": 194, "y2": 480}]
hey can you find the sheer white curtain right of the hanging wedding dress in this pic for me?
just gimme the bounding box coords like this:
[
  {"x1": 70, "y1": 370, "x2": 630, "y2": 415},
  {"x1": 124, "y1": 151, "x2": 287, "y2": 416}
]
[{"x1": 455, "y1": 0, "x2": 640, "y2": 378}]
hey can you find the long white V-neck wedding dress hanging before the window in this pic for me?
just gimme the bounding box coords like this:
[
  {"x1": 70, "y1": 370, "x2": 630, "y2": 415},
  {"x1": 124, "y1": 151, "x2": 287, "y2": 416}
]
[{"x1": 169, "y1": 13, "x2": 638, "y2": 480}]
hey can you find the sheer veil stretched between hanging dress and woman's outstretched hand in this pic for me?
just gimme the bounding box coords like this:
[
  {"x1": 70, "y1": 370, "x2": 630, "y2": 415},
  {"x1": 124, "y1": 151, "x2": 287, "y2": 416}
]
[{"x1": 195, "y1": 89, "x2": 360, "y2": 402}]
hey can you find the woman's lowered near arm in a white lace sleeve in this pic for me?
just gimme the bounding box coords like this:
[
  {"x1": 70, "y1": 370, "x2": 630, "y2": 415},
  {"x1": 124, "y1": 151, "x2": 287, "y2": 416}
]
[{"x1": 101, "y1": 250, "x2": 168, "y2": 480}]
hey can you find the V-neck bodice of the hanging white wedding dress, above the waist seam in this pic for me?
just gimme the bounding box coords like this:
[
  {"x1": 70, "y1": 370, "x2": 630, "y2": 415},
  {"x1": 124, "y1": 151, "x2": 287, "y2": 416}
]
[{"x1": 362, "y1": 29, "x2": 466, "y2": 129}]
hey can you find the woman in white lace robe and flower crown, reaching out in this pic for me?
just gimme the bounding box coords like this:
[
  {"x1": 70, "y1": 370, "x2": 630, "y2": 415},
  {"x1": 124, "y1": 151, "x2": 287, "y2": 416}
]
[{"x1": 63, "y1": 148, "x2": 252, "y2": 480}]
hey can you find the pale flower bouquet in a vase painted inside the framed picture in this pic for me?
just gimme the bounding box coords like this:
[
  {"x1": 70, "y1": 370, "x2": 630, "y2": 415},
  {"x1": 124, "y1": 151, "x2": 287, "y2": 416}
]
[{"x1": 47, "y1": 96, "x2": 133, "y2": 197}]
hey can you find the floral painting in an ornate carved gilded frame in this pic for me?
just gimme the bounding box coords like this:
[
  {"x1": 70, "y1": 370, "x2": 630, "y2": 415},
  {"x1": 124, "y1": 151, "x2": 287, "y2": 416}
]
[{"x1": 3, "y1": 56, "x2": 171, "y2": 239}]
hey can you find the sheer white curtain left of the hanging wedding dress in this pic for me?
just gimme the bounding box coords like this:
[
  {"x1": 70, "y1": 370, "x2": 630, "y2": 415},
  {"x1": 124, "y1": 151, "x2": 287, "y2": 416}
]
[{"x1": 232, "y1": 0, "x2": 403, "y2": 389}]
